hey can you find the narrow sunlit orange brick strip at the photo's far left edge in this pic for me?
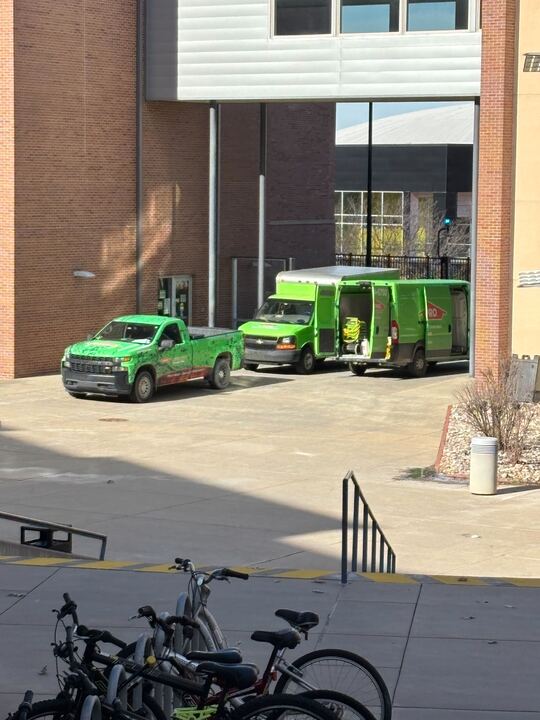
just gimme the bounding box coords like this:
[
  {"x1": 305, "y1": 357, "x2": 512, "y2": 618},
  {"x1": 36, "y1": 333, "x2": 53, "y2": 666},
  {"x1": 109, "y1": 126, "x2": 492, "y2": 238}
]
[{"x1": 0, "y1": 0, "x2": 15, "y2": 378}]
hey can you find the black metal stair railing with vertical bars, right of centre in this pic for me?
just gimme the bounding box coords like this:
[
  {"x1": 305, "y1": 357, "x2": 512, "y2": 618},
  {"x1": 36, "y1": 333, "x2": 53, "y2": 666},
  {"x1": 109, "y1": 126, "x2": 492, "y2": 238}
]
[{"x1": 341, "y1": 470, "x2": 396, "y2": 585}]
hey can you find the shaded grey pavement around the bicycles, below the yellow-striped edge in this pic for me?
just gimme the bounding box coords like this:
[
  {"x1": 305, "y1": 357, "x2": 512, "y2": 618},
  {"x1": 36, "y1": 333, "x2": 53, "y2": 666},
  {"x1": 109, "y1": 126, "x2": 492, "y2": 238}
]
[{"x1": 0, "y1": 563, "x2": 540, "y2": 720}]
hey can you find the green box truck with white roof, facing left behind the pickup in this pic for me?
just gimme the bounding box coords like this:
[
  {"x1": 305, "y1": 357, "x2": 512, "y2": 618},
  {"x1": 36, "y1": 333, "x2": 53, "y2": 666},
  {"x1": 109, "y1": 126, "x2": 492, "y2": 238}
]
[{"x1": 239, "y1": 266, "x2": 399, "y2": 374}]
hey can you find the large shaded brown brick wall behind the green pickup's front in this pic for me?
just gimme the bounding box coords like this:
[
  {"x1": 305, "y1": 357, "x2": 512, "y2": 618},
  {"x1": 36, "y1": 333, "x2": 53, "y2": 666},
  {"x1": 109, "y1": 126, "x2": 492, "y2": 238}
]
[{"x1": 15, "y1": 0, "x2": 136, "y2": 376}]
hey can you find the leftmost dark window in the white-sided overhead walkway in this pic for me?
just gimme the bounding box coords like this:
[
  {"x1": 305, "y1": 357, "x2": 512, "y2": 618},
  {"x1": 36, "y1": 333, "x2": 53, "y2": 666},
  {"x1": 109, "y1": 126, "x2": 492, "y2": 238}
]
[{"x1": 275, "y1": 0, "x2": 332, "y2": 35}]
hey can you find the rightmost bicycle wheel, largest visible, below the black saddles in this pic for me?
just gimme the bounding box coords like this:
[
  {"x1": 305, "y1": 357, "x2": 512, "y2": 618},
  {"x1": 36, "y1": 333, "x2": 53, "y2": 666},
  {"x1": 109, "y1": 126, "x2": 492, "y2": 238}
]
[{"x1": 274, "y1": 650, "x2": 392, "y2": 720}]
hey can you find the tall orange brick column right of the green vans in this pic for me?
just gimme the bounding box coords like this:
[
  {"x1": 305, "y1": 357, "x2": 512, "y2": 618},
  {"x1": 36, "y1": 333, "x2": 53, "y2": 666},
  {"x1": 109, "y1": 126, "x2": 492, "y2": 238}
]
[{"x1": 475, "y1": 0, "x2": 517, "y2": 376}]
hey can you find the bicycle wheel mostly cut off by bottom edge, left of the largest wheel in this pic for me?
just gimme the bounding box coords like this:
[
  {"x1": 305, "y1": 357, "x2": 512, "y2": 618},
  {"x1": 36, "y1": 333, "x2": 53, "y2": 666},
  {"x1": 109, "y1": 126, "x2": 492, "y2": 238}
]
[{"x1": 229, "y1": 695, "x2": 336, "y2": 720}]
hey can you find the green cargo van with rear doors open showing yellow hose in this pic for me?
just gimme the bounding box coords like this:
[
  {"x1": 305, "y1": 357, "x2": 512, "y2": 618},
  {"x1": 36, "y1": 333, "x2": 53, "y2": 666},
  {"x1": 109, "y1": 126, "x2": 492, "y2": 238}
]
[{"x1": 338, "y1": 280, "x2": 469, "y2": 377}]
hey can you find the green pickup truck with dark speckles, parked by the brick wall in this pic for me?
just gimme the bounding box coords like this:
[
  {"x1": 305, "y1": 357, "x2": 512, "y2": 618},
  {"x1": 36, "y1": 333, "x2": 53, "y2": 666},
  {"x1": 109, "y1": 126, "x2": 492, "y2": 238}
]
[{"x1": 62, "y1": 315, "x2": 244, "y2": 403}]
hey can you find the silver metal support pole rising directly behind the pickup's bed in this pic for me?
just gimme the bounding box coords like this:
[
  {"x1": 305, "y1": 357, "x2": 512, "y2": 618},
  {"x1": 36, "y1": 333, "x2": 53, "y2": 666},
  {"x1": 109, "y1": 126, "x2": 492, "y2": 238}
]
[{"x1": 208, "y1": 101, "x2": 218, "y2": 327}]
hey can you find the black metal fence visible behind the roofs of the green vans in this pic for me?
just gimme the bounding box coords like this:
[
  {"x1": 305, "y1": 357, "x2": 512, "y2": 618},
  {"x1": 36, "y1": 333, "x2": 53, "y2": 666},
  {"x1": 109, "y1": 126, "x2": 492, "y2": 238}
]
[{"x1": 336, "y1": 253, "x2": 471, "y2": 280}]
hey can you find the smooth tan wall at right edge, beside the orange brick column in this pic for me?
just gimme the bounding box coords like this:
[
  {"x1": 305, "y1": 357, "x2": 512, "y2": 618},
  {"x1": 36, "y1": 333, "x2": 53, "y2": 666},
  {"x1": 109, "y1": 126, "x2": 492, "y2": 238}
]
[{"x1": 512, "y1": 0, "x2": 540, "y2": 355}]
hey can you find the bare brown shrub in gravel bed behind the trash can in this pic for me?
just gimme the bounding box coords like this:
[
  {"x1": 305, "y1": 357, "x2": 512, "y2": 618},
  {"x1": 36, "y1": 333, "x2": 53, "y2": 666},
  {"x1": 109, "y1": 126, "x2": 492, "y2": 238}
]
[{"x1": 457, "y1": 360, "x2": 534, "y2": 464}]
